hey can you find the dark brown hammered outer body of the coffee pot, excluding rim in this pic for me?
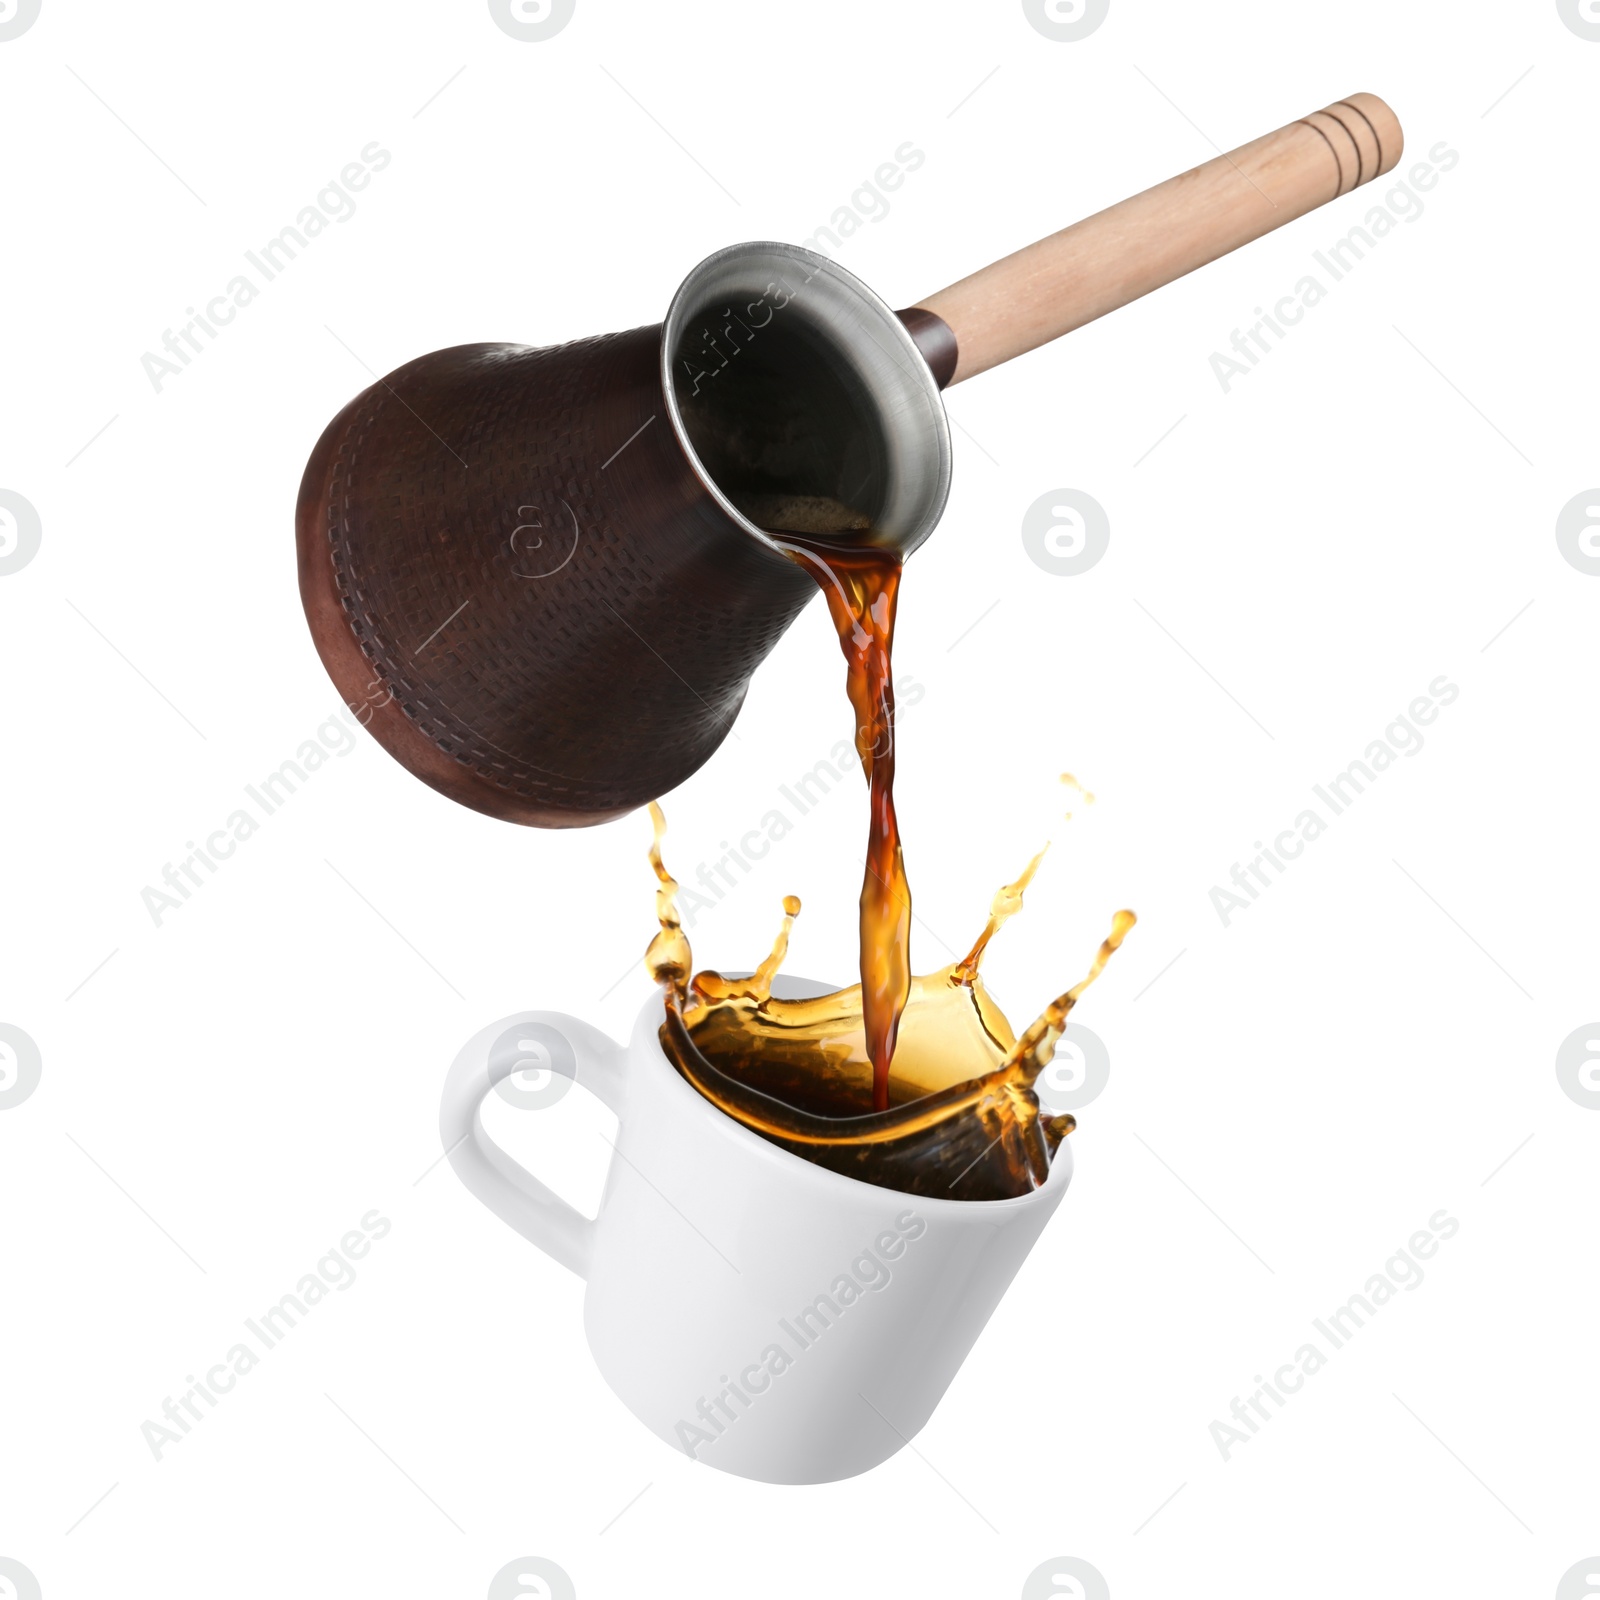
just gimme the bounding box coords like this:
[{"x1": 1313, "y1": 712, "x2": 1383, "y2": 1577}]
[{"x1": 299, "y1": 328, "x2": 814, "y2": 826}]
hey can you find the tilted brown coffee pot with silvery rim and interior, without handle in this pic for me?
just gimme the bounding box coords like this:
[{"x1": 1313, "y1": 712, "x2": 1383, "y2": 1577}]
[{"x1": 298, "y1": 246, "x2": 949, "y2": 827}]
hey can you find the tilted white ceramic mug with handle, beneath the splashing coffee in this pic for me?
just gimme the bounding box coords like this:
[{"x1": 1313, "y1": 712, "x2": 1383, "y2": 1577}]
[{"x1": 440, "y1": 979, "x2": 1072, "y2": 1483}]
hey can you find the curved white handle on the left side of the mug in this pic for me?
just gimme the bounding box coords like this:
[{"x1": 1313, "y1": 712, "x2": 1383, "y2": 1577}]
[{"x1": 438, "y1": 1011, "x2": 627, "y2": 1278}]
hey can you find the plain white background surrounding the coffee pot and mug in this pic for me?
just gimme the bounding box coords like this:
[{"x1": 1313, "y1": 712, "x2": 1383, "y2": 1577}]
[{"x1": 0, "y1": 0, "x2": 1600, "y2": 1600}]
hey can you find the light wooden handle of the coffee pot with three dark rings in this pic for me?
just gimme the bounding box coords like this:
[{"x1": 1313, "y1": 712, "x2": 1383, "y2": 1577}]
[{"x1": 914, "y1": 94, "x2": 1405, "y2": 384}]
